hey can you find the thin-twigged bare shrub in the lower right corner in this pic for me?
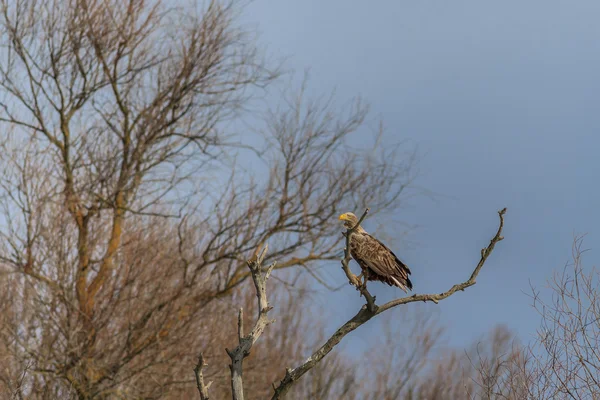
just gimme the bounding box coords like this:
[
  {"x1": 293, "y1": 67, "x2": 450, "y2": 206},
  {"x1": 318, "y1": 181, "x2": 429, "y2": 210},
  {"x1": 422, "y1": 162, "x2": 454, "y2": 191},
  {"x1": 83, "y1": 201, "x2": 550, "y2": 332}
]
[{"x1": 476, "y1": 236, "x2": 600, "y2": 400}]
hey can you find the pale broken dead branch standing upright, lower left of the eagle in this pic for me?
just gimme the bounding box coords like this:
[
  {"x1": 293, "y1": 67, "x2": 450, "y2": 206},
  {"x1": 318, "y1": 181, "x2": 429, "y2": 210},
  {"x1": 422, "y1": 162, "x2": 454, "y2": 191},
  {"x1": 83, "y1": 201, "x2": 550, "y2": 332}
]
[{"x1": 225, "y1": 246, "x2": 275, "y2": 400}]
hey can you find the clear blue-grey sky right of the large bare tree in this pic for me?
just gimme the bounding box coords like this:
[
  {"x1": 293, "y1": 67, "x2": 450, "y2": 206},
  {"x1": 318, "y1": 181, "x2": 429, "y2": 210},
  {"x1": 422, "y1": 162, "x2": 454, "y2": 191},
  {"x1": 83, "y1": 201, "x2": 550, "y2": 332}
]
[{"x1": 237, "y1": 0, "x2": 600, "y2": 354}]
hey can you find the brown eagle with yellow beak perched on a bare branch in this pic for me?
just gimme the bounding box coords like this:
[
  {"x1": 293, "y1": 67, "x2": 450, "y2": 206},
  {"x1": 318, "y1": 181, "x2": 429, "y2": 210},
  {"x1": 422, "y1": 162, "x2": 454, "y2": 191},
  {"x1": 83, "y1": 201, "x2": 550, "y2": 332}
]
[{"x1": 339, "y1": 212, "x2": 412, "y2": 293}]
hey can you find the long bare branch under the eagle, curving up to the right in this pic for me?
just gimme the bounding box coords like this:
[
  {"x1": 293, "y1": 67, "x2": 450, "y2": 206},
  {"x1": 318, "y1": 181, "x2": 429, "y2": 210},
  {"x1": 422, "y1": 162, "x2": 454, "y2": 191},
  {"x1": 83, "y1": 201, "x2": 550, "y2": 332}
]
[{"x1": 271, "y1": 208, "x2": 506, "y2": 400}]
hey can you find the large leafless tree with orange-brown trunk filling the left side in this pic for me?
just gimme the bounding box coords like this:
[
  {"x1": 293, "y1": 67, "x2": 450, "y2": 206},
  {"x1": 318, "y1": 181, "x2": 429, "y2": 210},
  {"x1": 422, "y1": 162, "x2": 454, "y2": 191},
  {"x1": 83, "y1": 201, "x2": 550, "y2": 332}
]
[{"x1": 0, "y1": 0, "x2": 414, "y2": 399}]
